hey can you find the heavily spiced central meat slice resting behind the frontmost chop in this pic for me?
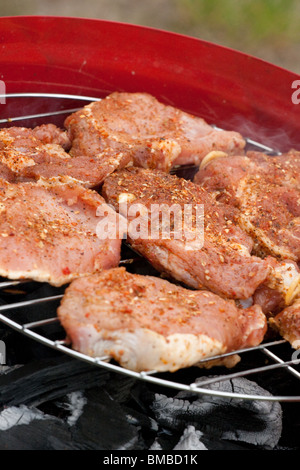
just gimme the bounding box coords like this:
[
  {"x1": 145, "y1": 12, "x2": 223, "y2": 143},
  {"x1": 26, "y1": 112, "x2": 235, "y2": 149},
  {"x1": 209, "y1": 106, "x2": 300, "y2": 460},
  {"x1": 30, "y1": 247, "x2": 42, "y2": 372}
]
[{"x1": 102, "y1": 167, "x2": 271, "y2": 299}]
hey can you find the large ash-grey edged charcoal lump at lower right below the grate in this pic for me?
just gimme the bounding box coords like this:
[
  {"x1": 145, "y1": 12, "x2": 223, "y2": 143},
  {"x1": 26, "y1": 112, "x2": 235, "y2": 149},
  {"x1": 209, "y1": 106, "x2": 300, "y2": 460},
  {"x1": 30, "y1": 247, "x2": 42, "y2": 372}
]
[{"x1": 151, "y1": 378, "x2": 282, "y2": 449}]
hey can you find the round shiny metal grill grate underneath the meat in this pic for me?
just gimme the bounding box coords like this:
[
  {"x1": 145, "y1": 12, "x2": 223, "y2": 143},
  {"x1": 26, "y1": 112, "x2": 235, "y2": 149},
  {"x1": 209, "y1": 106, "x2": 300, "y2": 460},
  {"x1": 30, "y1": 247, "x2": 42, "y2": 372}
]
[{"x1": 0, "y1": 93, "x2": 300, "y2": 402}]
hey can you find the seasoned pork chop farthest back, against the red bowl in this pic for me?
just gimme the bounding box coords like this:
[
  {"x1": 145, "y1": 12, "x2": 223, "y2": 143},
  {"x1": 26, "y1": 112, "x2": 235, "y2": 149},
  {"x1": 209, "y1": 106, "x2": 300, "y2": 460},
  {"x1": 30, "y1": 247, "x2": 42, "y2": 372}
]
[{"x1": 65, "y1": 92, "x2": 245, "y2": 174}]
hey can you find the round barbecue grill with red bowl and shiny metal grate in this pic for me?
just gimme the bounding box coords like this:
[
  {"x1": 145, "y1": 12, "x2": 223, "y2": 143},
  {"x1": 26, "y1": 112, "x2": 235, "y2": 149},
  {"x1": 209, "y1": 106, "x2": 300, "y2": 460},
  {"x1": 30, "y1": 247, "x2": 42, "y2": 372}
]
[{"x1": 0, "y1": 17, "x2": 300, "y2": 452}]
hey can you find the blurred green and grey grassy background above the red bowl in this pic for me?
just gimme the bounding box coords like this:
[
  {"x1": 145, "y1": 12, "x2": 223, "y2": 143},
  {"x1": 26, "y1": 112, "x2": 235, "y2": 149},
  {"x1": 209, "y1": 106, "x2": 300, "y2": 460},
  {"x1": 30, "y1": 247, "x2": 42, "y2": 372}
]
[{"x1": 0, "y1": 0, "x2": 300, "y2": 73}]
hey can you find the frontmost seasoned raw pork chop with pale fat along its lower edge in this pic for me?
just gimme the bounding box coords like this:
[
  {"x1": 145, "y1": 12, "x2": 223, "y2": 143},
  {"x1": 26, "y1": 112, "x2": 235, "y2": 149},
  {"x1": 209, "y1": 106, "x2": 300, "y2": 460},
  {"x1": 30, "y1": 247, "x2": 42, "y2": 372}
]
[{"x1": 58, "y1": 268, "x2": 266, "y2": 372}]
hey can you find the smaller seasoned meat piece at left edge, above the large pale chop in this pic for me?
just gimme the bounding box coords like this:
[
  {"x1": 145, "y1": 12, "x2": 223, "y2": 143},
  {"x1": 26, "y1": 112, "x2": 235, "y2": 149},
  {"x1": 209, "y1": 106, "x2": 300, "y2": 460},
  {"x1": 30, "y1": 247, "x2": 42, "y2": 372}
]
[{"x1": 0, "y1": 124, "x2": 112, "y2": 188}]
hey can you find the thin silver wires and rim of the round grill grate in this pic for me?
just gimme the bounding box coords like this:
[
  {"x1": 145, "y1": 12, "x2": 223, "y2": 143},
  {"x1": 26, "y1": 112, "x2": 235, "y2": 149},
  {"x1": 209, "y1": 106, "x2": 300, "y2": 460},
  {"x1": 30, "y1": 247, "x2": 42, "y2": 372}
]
[{"x1": 0, "y1": 93, "x2": 300, "y2": 402}]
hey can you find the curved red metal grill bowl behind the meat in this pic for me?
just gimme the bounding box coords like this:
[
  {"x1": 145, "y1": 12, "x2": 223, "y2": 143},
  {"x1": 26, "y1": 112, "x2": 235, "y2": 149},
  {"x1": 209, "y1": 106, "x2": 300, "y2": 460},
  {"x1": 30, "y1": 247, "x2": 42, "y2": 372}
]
[{"x1": 0, "y1": 16, "x2": 300, "y2": 151}]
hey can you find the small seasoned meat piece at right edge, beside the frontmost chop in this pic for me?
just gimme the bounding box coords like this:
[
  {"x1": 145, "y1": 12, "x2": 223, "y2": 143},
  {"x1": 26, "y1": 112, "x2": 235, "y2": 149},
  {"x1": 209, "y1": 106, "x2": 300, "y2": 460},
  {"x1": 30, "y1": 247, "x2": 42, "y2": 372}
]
[{"x1": 269, "y1": 299, "x2": 300, "y2": 349}]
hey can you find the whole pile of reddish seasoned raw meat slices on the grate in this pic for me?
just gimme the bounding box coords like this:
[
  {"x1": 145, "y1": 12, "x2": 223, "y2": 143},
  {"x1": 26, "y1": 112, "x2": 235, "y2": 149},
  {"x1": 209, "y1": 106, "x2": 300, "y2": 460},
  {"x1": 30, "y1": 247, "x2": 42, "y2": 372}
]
[{"x1": 0, "y1": 92, "x2": 299, "y2": 371}]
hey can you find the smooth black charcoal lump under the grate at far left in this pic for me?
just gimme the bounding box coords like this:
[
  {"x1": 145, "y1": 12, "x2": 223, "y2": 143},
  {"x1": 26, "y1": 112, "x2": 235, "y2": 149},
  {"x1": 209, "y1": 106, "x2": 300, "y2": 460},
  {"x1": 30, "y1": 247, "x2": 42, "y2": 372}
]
[{"x1": 0, "y1": 356, "x2": 109, "y2": 407}]
